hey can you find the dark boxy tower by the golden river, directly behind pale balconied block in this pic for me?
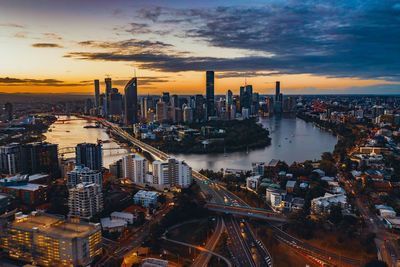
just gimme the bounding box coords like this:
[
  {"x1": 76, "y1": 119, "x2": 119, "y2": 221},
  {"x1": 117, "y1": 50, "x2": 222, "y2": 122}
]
[{"x1": 75, "y1": 143, "x2": 103, "y2": 170}]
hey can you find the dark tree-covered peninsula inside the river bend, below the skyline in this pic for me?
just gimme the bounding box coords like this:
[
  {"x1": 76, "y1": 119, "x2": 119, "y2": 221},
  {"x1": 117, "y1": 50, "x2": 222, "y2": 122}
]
[{"x1": 143, "y1": 119, "x2": 271, "y2": 154}]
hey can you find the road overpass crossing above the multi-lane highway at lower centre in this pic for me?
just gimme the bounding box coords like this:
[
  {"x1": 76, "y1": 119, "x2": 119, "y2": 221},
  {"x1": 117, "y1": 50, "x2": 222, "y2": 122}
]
[{"x1": 206, "y1": 202, "x2": 287, "y2": 222}]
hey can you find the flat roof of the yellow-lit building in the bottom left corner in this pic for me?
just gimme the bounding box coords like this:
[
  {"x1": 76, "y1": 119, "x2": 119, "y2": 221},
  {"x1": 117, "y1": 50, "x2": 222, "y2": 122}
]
[{"x1": 10, "y1": 213, "x2": 98, "y2": 239}]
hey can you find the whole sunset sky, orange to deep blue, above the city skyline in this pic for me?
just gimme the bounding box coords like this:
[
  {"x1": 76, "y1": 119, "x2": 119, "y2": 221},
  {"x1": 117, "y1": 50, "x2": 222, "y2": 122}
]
[{"x1": 0, "y1": 0, "x2": 400, "y2": 94}]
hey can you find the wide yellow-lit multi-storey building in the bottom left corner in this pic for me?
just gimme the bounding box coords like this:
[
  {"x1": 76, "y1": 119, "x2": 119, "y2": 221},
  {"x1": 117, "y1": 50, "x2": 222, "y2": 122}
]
[{"x1": 1, "y1": 212, "x2": 102, "y2": 266}]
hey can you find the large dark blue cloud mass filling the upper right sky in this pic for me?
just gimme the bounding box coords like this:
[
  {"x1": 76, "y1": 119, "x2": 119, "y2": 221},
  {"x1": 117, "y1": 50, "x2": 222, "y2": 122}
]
[{"x1": 114, "y1": 0, "x2": 400, "y2": 81}]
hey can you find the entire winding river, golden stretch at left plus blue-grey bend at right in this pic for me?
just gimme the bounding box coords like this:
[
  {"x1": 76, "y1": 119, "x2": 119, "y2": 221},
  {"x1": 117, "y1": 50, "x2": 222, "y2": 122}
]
[{"x1": 45, "y1": 116, "x2": 337, "y2": 170}]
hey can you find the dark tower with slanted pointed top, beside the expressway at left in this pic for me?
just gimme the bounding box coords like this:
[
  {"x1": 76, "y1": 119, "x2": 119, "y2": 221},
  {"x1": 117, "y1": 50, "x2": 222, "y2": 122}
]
[{"x1": 124, "y1": 77, "x2": 138, "y2": 125}]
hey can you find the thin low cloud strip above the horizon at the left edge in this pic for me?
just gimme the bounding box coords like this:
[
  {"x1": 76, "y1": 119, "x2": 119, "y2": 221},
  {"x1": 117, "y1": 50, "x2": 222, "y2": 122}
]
[{"x1": 0, "y1": 77, "x2": 90, "y2": 87}]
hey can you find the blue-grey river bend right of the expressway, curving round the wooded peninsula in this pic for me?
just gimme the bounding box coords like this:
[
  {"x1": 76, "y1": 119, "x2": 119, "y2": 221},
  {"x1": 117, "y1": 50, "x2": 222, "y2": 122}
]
[{"x1": 169, "y1": 117, "x2": 338, "y2": 170}]
